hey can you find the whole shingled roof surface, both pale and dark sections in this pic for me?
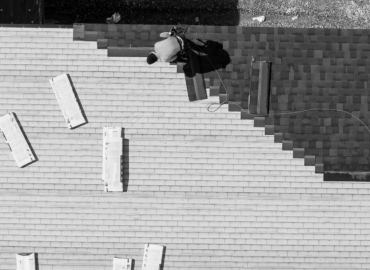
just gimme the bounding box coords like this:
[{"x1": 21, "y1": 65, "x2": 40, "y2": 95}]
[{"x1": 0, "y1": 25, "x2": 370, "y2": 270}]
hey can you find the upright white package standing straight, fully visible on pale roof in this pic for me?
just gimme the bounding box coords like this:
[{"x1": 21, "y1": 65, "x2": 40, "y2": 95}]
[{"x1": 102, "y1": 127, "x2": 123, "y2": 191}]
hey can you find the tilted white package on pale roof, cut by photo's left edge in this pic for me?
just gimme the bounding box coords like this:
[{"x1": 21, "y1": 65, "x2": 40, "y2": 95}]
[{"x1": 0, "y1": 112, "x2": 36, "y2": 168}]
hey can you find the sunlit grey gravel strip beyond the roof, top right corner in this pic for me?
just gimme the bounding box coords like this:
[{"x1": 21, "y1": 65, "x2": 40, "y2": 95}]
[{"x1": 238, "y1": 0, "x2": 370, "y2": 28}]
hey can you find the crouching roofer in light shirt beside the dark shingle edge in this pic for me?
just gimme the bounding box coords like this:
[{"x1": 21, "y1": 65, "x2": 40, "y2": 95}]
[{"x1": 146, "y1": 27, "x2": 188, "y2": 65}]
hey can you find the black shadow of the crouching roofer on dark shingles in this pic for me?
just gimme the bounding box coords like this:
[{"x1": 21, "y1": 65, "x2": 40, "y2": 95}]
[{"x1": 178, "y1": 39, "x2": 231, "y2": 77}]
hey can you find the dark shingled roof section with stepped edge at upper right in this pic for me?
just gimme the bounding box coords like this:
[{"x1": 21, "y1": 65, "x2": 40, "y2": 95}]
[{"x1": 74, "y1": 24, "x2": 370, "y2": 179}]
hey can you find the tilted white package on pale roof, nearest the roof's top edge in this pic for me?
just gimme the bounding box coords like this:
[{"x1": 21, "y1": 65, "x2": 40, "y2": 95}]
[{"x1": 49, "y1": 74, "x2": 86, "y2": 128}]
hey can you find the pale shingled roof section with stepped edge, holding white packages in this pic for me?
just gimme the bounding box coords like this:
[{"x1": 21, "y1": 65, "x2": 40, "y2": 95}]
[{"x1": 0, "y1": 23, "x2": 370, "y2": 270}]
